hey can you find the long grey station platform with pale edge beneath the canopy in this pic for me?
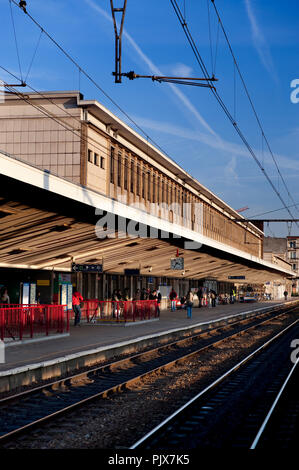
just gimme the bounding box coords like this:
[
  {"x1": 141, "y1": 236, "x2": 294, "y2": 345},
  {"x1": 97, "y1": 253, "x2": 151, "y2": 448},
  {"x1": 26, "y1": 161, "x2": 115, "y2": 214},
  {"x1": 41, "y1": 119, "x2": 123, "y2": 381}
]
[{"x1": 0, "y1": 298, "x2": 299, "y2": 392}]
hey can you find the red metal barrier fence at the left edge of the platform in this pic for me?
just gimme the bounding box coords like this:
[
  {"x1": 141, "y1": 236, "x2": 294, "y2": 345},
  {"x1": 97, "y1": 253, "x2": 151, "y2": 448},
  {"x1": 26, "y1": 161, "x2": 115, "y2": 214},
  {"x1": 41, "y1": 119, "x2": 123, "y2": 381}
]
[{"x1": 0, "y1": 305, "x2": 69, "y2": 341}]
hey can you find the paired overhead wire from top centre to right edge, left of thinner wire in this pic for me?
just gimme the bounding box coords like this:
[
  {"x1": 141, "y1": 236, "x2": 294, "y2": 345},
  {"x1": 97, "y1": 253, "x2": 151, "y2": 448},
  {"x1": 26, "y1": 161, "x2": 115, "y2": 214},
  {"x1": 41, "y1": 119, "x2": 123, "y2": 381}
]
[{"x1": 170, "y1": 0, "x2": 299, "y2": 227}]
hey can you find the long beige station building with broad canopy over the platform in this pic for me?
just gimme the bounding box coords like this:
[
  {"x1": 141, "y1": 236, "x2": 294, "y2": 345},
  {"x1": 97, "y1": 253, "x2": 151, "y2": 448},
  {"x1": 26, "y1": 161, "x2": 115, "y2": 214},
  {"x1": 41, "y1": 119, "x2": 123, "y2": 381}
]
[{"x1": 0, "y1": 92, "x2": 294, "y2": 391}]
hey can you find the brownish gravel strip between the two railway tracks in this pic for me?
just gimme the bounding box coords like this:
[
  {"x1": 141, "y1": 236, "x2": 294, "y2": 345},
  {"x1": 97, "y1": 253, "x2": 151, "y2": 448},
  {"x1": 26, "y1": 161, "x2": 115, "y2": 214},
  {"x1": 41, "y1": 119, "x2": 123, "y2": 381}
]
[{"x1": 5, "y1": 313, "x2": 297, "y2": 449}]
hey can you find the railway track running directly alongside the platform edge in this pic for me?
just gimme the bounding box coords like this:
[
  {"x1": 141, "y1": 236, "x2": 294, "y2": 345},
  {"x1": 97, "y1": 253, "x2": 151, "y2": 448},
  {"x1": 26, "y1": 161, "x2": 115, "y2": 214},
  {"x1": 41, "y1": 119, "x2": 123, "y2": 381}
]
[{"x1": 0, "y1": 307, "x2": 296, "y2": 445}]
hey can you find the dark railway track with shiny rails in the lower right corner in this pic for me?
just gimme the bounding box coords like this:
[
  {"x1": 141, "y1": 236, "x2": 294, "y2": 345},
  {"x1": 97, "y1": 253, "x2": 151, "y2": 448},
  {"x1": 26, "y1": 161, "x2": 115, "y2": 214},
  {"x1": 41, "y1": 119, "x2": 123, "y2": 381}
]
[{"x1": 130, "y1": 319, "x2": 299, "y2": 451}]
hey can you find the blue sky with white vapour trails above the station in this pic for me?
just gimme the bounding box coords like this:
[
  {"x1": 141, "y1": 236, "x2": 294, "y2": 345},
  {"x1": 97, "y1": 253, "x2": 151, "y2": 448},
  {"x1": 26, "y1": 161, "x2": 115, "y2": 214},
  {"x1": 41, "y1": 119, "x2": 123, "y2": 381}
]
[{"x1": 0, "y1": 0, "x2": 299, "y2": 236}]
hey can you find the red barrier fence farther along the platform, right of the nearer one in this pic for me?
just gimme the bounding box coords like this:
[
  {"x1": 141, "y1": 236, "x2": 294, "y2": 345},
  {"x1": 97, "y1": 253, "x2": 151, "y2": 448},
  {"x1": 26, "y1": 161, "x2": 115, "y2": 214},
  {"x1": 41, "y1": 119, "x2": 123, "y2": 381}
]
[{"x1": 72, "y1": 299, "x2": 159, "y2": 323}]
